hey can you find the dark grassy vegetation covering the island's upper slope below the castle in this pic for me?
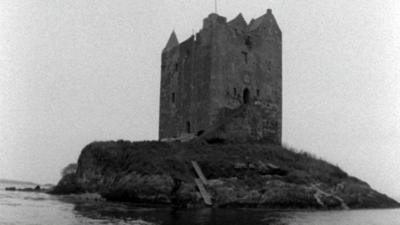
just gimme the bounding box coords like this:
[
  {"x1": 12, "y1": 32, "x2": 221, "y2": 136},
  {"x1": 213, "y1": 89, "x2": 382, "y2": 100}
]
[{"x1": 76, "y1": 141, "x2": 348, "y2": 184}]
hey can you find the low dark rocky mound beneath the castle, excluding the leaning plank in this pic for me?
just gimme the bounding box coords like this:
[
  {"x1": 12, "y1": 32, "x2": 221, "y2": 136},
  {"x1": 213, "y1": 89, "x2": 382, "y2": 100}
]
[{"x1": 54, "y1": 141, "x2": 399, "y2": 209}]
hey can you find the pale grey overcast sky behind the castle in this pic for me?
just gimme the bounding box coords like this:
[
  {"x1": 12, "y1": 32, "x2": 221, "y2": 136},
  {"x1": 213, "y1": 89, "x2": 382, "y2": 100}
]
[{"x1": 0, "y1": 0, "x2": 400, "y2": 196}]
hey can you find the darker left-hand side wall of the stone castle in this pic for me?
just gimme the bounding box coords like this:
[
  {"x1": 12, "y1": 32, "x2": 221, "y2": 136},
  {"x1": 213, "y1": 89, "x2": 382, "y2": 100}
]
[{"x1": 159, "y1": 31, "x2": 216, "y2": 139}]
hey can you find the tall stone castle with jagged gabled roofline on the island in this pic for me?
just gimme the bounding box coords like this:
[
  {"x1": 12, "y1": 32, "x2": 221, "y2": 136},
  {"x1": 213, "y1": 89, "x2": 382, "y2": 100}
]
[{"x1": 159, "y1": 9, "x2": 282, "y2": 144}]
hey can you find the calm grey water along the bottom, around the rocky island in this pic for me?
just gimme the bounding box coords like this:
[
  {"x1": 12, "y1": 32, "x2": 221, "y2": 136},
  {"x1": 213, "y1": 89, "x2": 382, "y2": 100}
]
[{"x1": 0, "y1": 189, "x2": 400, "y2": 225}]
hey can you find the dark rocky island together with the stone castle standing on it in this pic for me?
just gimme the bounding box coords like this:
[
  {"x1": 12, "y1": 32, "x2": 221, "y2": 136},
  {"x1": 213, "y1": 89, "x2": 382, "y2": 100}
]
[{"x1": 53, "y1": 9, "x2": 400, "y2": 209}]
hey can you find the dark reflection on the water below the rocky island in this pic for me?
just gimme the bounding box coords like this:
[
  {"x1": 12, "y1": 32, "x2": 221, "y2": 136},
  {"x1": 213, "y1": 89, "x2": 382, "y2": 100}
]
[{"x1": 74, "y1": 202, "x2": 288, "y2": 225}]
